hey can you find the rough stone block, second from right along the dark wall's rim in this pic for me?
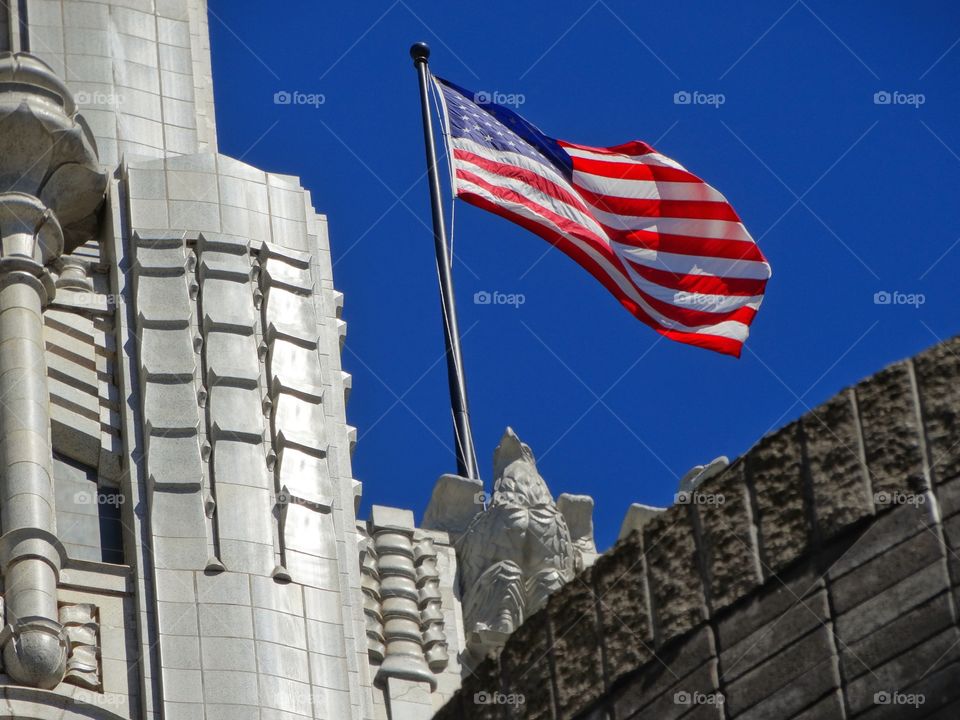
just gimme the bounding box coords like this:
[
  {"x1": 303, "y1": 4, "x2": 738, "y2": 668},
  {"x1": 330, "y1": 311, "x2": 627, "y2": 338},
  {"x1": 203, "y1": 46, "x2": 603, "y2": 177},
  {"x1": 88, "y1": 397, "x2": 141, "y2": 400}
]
[{"x1": 856, "y1": 362, "x2": 924, "y2": 494}]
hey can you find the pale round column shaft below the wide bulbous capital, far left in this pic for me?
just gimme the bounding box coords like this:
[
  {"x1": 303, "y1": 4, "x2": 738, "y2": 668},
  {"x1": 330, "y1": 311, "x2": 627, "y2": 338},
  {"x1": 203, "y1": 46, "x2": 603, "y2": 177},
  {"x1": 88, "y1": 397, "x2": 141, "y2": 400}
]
[{"x1": 0, "y1": 193, "x2": 67, "y2": 688}]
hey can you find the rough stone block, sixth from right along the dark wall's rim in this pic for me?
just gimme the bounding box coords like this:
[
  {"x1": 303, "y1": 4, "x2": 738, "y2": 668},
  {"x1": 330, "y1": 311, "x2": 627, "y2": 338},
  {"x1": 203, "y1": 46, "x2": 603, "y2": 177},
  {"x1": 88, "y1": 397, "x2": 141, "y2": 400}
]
[{"x1": 643, "y1": 505, "x2": 707, "y2": 647}]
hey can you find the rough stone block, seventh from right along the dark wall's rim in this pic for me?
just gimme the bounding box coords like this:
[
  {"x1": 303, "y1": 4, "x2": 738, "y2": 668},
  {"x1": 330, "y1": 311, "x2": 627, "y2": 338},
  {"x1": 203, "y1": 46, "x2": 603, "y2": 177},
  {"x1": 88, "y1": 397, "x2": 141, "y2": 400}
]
[{"x1": 592, "y1": 533, "x2": 653, "y2": 683}]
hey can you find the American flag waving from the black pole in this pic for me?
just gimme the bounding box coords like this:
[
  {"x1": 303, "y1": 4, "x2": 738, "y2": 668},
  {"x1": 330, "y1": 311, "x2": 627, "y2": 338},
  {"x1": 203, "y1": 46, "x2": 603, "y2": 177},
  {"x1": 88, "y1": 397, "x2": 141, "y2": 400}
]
[{"x1": 433, "y1": 76, "x2": 770, "y2": 357}]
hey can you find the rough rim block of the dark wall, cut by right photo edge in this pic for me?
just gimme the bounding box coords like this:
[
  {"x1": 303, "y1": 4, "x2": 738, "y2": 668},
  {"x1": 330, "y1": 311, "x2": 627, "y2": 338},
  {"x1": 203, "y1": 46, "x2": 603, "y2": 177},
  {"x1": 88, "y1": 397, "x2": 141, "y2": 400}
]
[{"x1": 913, "y1": 338, "x2": 960, "y2": 482}]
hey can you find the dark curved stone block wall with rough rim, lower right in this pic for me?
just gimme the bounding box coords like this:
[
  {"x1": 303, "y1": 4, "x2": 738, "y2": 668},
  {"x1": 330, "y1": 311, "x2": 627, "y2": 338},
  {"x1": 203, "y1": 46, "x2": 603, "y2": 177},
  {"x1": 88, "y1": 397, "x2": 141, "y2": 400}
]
[{"x1": 436, "y1": 338, "x2": 960, "y2": 720}]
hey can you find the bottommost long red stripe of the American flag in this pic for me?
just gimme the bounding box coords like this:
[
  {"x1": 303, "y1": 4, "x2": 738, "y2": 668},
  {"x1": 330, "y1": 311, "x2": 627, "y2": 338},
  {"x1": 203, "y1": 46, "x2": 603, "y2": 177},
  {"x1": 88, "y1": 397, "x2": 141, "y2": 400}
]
[{"x1": 460, "y1": 192, "x2": 743, "y2": 358}]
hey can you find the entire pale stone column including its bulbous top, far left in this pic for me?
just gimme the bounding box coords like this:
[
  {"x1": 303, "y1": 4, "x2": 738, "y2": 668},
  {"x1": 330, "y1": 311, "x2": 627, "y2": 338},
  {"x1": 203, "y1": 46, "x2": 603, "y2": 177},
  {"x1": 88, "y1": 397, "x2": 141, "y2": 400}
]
[{"x1": 0, "y1": 53, "x2": 106, "y2": 688}]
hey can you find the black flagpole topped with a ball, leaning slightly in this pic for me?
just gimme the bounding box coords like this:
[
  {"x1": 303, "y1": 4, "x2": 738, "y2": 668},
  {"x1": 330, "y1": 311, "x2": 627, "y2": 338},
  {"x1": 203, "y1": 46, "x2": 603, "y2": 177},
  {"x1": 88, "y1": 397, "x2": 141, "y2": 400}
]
[{"x1": 410, "y1": 42, "x2": 480, "y2": 480}]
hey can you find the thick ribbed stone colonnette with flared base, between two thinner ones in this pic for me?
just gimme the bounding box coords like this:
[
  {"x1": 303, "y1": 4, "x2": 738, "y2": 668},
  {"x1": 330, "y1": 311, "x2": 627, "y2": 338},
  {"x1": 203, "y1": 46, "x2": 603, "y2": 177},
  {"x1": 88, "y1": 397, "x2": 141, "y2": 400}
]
[{"x1": 372, "y1": 506, "x2": 437, "y2": 689}]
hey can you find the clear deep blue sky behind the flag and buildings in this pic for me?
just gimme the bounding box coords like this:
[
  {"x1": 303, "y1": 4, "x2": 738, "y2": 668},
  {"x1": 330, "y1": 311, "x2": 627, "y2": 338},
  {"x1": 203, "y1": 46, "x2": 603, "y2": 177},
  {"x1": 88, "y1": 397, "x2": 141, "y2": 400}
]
[{"x1": 210, "y1": 0, "x2": 960, "y2": 547}]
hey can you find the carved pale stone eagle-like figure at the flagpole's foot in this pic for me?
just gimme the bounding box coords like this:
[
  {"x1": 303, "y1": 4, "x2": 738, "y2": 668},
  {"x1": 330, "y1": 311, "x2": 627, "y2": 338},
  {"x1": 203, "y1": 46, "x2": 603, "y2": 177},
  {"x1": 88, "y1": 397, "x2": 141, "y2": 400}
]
[{"x1": 457, "y1": 428, "x2": 581, "y2": 662}]
